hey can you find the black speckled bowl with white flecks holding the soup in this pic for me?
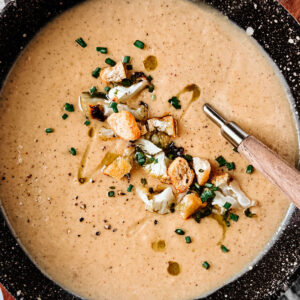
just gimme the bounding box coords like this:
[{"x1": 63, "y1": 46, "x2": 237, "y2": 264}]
[{"x1": 0, "y1": 0, "x2": 300, "y2": 300}]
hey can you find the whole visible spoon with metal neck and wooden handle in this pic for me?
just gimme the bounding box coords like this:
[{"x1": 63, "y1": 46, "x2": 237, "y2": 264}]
[{"x1": 203, "y1": 103, "x2": 300, "y2": 208}]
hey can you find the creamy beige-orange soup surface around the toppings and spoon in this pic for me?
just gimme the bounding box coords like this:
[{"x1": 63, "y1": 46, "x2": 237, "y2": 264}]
[{"x1": 0, "y1": 0, "x2": 298, "y2": 299}]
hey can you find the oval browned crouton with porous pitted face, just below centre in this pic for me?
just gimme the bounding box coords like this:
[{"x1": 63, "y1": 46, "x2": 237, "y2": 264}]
[{"x1": 168, "y1": 157, "x2": 195, "y2": 193}]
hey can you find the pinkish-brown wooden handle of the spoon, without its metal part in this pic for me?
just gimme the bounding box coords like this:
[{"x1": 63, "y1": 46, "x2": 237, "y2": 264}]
[{"x1": 238, "y1": 136, "x2": 300, "y2": 208}]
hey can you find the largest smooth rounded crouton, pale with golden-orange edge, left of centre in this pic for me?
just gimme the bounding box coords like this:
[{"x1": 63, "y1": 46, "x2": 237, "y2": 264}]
[{"x1": 107, "y1": 111, "x2": 141, "y2": 141}]
